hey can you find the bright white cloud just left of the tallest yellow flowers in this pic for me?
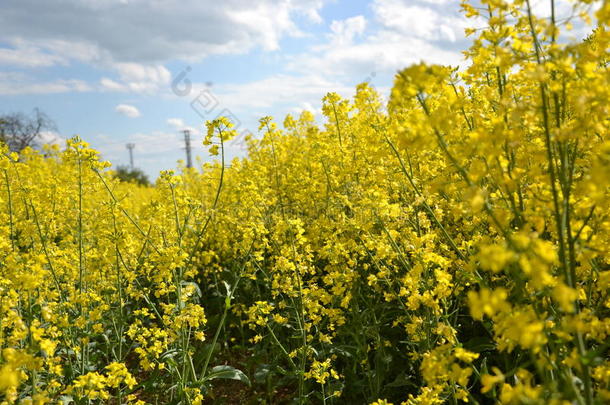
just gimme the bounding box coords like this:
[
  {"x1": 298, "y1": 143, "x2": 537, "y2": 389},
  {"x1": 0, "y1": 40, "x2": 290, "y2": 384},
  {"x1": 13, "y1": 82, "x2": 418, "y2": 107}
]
[{"x1": 286, "y1": 0, "x2": 469, "y2": 86}]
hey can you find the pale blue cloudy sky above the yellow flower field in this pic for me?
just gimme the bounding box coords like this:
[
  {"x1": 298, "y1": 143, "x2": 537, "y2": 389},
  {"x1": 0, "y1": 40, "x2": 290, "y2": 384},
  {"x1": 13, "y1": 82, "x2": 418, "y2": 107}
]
[{"x1": 0, "y1": 0, "x2": 524, "y2": 177}]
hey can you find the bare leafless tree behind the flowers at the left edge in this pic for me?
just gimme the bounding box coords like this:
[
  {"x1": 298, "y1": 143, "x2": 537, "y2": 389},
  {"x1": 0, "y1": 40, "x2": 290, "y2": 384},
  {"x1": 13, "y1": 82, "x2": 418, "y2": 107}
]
[{"x1": 0, "y1": 108, "x2": 57, "y2": 152}]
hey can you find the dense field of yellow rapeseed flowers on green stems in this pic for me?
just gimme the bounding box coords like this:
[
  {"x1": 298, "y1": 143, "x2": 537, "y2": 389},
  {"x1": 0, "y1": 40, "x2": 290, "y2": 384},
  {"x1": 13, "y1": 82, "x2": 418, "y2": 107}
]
[{"x1": 0, "y1": 0, "x2": 610, "y2": 405}]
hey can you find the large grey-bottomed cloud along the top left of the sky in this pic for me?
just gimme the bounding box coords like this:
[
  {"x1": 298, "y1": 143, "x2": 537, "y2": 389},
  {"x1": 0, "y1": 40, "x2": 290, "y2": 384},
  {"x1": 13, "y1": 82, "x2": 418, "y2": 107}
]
[{"x1": 0, "y1": 0, "x2": 328, "y2": 65}]
